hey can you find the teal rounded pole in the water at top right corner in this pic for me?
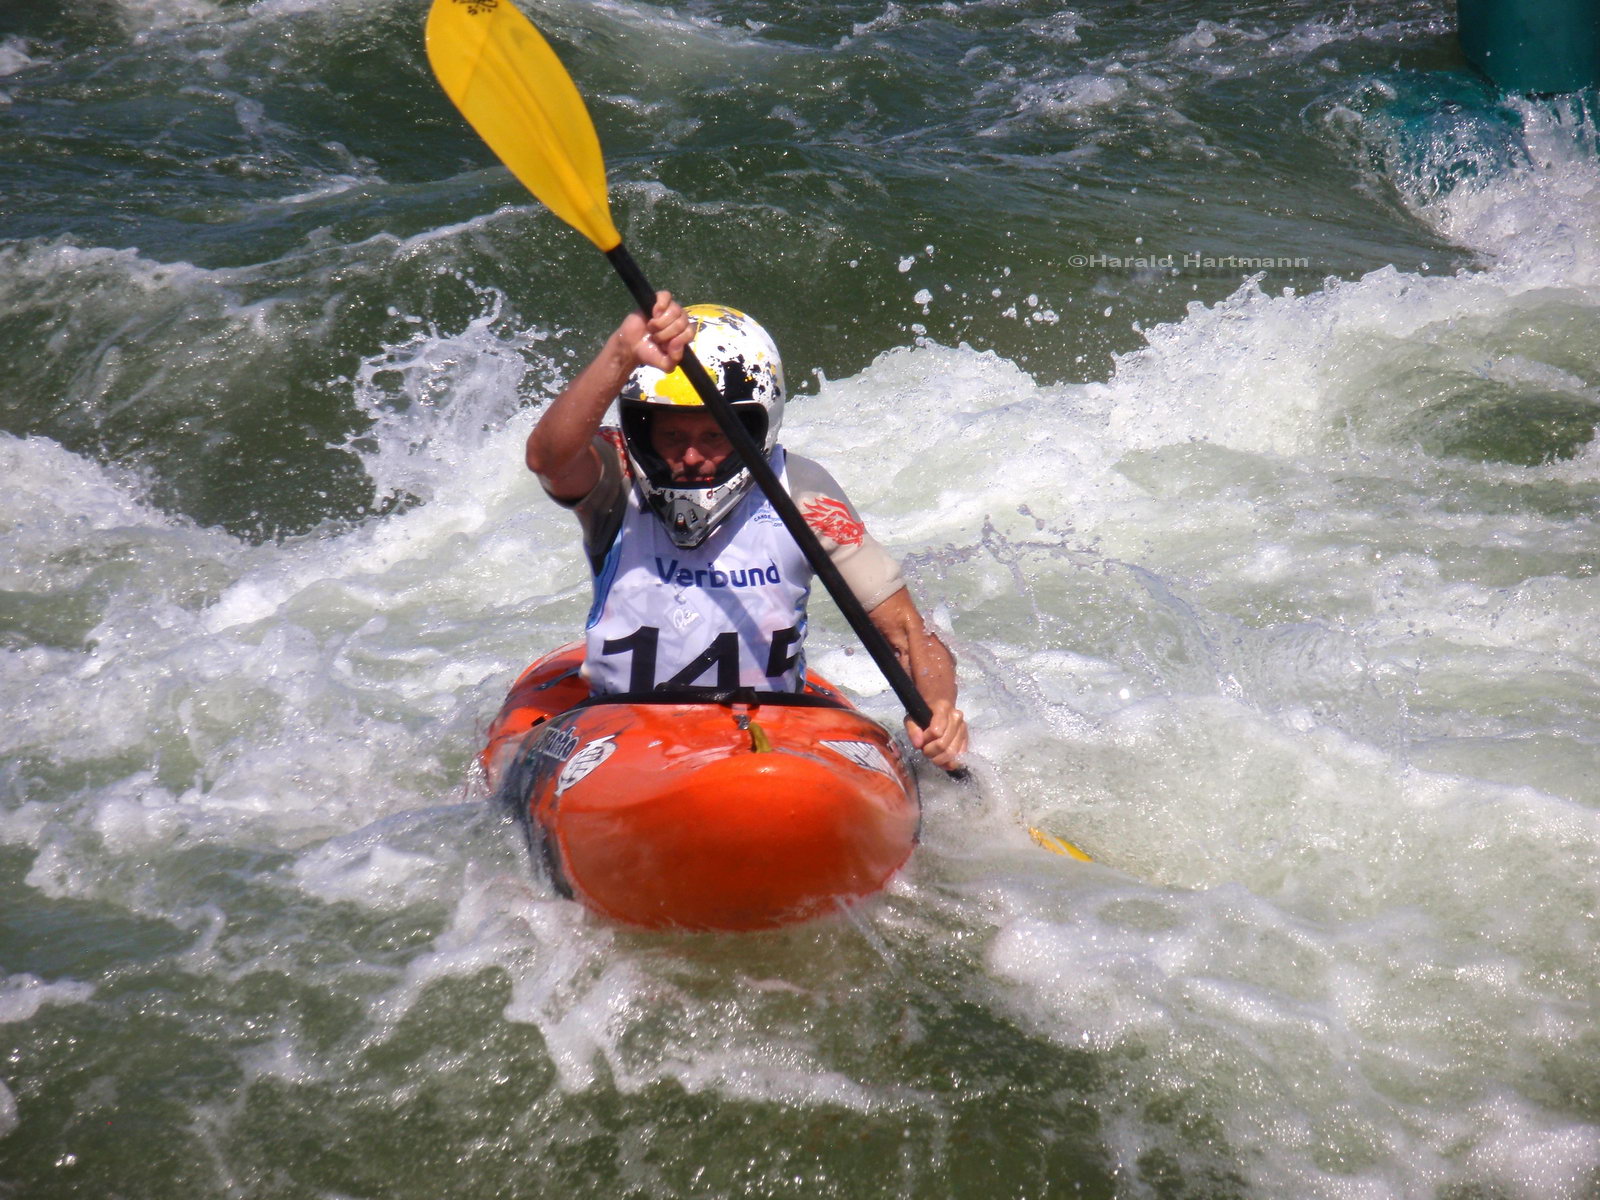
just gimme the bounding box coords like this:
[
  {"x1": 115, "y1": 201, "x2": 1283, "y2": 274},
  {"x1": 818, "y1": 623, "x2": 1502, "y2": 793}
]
[{"x1": 1456, "y1": 0, "x2": 1600, "y2": 96}]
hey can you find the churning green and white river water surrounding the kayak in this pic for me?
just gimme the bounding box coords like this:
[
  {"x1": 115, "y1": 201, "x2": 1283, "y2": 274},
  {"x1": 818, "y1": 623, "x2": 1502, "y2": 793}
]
[{"x1": 0, "y1": 0, "x2": 1600, "y2": 1200}]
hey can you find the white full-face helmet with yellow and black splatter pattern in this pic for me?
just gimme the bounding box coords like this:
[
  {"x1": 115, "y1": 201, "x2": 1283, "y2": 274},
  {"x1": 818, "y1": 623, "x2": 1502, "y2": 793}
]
[{"x1": 621, "y1": 304, "x2": 784, "y2": 549}]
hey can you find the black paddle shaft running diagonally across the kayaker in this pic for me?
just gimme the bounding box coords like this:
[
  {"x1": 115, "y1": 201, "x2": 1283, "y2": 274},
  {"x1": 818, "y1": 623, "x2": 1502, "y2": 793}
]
[{"x1": 605, "y1": 243, "x2": 933, "y2": 728}]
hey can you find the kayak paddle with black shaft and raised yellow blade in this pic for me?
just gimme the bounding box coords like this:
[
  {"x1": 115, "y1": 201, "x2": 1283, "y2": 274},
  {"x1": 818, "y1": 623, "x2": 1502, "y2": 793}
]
[{"x1": 427, "y1": 0, "x2": 933, "y2": 742}]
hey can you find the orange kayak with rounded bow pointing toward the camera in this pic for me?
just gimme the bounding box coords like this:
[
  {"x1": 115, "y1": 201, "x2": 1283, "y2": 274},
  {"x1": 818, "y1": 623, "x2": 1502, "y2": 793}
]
[{"x1": 482, "y1": 645, "x2": 922, "y2": 930}]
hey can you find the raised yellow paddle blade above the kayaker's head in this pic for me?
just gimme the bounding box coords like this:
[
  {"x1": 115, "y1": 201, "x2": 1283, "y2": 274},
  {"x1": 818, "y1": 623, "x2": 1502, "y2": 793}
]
[{"x1": 427, "y1": 0, "x2": 622, "y2": 251}]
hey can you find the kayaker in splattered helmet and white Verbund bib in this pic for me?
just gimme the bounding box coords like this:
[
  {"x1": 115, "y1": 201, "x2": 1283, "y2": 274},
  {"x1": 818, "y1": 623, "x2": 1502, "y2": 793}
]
[{"x1": 526, "y1": 291, "x2": 966, "y2": 770}]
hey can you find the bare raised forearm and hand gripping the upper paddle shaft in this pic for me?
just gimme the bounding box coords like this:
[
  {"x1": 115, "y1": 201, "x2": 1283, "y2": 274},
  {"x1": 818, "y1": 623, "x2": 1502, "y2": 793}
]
[{"x1": 526, "y1": 291, "x2": 693, "y2": 501}]
